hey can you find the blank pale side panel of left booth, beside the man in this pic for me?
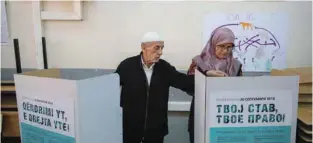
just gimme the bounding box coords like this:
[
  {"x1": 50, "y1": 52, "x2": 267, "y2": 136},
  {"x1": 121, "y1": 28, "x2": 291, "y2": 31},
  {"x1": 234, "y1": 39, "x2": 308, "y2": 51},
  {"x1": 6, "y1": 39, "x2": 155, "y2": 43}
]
[{"x1": 77, "y1": 74, "x2": 123, "y2": 143}]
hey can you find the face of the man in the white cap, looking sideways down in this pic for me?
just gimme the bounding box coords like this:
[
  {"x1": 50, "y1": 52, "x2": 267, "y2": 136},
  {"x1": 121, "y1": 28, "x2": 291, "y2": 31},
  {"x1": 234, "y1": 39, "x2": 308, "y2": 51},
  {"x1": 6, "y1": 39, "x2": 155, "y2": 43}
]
[{"x1": 141, "y1": 41, "x2": 164, "y2": 64}]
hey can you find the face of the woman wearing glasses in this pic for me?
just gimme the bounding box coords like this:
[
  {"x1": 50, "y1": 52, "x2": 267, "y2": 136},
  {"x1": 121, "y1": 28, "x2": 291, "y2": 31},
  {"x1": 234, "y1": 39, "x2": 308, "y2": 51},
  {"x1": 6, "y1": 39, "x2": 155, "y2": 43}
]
[{"x1": 215, "y1": 43, "x2": 234, "y2": 59}]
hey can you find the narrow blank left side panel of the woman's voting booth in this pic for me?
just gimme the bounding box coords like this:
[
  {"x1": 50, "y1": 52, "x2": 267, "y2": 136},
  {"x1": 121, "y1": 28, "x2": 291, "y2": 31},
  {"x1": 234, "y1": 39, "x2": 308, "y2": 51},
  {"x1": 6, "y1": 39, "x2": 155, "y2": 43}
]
[{"x1": 194, "y1": 70, "x2": 206, "y2": 143}]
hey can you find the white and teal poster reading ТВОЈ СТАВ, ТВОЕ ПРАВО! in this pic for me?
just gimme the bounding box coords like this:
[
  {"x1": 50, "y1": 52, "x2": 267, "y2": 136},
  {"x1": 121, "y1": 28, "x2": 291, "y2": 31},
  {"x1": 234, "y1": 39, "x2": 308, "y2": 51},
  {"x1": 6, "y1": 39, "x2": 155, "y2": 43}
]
[{"x1": 206, "y1": 90, "x2": 296, "y2": 143}]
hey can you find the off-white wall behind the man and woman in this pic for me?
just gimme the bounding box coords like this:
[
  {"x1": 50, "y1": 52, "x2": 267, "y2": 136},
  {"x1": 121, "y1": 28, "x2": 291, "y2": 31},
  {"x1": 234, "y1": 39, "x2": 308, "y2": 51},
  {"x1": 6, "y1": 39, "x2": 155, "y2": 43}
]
[{"x1": 2, "y1": 1, "x2": 312, "y2": 69}]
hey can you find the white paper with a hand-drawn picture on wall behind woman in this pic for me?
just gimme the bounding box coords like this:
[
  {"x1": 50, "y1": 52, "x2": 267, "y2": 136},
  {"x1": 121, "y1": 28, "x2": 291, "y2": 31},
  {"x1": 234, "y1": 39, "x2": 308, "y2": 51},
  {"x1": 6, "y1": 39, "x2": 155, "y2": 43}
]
[{"x1": 203, "y1": 13, "x2": 288, "y2": 72}]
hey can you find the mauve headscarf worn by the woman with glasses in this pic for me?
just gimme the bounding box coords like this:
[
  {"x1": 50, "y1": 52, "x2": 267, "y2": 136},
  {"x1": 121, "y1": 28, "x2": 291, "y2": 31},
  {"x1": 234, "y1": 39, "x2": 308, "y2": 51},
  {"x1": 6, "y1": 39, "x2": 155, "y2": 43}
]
[{"x1": 193, "y1": 27, "x2": 241, "y2": 76}]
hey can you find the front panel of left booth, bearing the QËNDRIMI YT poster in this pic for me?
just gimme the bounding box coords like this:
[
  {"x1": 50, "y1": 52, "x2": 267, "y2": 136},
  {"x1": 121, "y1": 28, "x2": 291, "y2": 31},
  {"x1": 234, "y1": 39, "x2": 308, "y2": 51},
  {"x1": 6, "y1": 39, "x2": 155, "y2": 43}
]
[{"x1": 14, "y1": 75, "x2": 76, "y2": 143}]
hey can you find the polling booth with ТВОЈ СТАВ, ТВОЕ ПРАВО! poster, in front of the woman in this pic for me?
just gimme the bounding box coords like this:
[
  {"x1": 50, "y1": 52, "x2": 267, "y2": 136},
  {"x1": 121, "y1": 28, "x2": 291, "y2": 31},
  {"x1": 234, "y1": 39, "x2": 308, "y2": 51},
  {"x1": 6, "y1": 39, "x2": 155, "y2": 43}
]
[{"x1": 195, "y1": 71, "x2": 299, "y2": 143}]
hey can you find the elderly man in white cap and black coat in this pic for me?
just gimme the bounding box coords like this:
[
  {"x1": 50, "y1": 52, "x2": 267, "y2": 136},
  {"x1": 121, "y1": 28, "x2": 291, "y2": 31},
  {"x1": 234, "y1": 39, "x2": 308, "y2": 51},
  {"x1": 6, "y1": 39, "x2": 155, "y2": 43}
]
[{"x1": 116, "y1": 32, "x2": 194, "y2": 143}]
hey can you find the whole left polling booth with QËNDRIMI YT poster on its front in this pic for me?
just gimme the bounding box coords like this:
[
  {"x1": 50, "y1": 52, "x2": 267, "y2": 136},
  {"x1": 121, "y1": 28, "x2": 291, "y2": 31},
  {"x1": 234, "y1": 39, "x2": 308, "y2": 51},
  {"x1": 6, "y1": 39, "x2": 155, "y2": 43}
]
[{"x1": 14, "y1": 69, "x2": 122, "y2": 143}]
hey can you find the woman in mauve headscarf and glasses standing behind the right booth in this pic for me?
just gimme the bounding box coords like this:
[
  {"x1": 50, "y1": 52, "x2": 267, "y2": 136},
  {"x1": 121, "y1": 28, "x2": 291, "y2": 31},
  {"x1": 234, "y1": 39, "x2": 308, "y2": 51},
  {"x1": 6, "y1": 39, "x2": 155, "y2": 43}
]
[{"x1": 188, "y1": 27, "x2": 242, "y2": 143}]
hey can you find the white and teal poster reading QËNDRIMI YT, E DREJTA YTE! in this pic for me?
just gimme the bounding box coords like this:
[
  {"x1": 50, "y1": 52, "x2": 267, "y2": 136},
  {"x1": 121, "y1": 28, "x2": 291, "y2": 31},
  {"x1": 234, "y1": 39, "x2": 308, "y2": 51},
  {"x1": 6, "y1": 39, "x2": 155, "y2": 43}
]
[{"x1": 18, "y1": 96, "x2": 75, "y2": 143}]
